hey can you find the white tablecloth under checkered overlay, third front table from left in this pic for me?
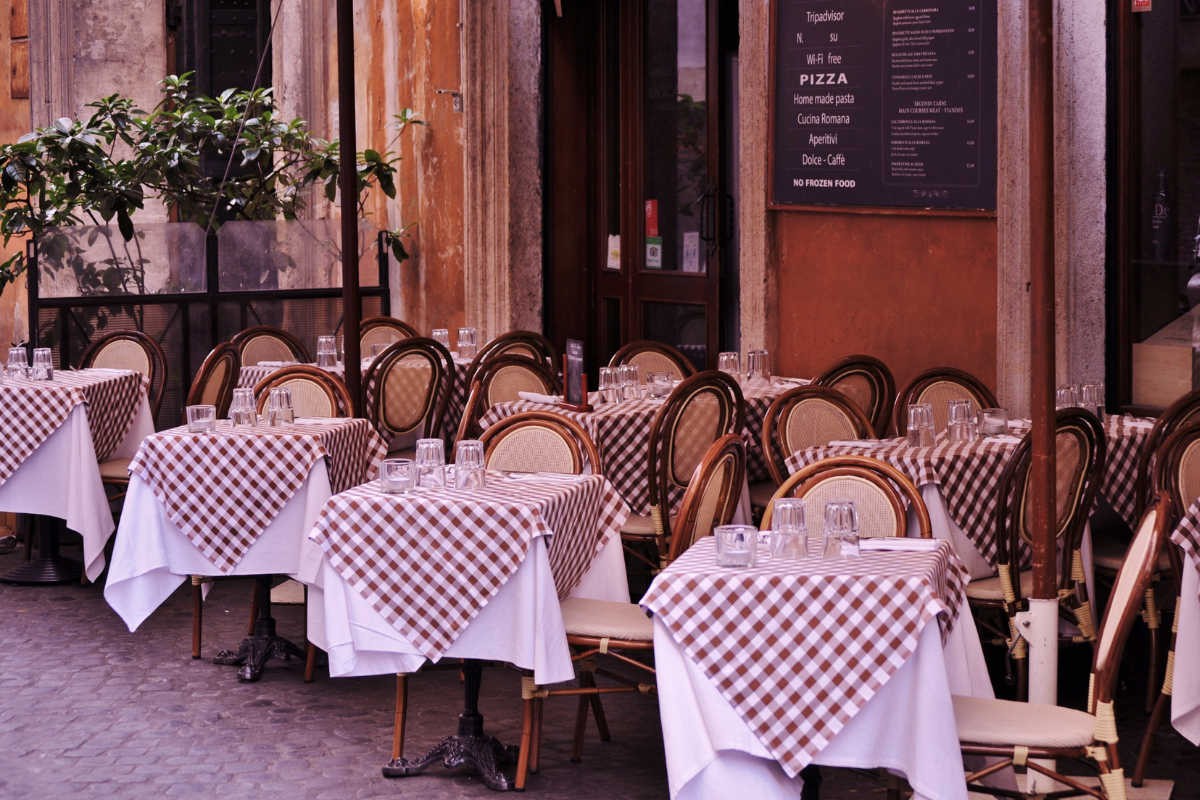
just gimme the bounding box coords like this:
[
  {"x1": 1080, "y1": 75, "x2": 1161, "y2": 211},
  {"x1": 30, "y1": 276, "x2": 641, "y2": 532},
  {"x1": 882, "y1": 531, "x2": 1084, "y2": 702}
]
[{"x1": 299, "y1": 525, "x2": 629, "y2": 684}]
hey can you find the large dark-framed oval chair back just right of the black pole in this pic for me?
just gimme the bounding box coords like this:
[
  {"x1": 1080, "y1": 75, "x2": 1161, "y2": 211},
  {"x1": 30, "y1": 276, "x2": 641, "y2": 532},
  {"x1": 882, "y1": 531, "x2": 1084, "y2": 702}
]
[{"x1": 362, "y1": 327, "x2": 455, "y2": 437}]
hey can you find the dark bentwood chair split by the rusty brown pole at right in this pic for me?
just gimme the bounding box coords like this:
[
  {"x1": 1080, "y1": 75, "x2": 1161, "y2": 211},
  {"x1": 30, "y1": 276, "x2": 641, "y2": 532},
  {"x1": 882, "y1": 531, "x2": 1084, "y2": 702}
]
[{"x1": 967, "y1": 408, "x2": 1106, "y2": 698}]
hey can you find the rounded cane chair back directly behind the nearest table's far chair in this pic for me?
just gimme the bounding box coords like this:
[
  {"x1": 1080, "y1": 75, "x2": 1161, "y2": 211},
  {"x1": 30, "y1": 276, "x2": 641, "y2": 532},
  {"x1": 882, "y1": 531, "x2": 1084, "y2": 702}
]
[{"x1": 762, "y1": 386, "x2": 875, "y2": 486}]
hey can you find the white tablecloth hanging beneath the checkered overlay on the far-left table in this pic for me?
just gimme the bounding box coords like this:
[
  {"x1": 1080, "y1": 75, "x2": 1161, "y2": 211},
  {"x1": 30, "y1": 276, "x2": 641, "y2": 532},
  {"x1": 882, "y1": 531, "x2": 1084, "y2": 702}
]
[{"x1": 0, "y1": 397, "x2": 154, "y2": 581}]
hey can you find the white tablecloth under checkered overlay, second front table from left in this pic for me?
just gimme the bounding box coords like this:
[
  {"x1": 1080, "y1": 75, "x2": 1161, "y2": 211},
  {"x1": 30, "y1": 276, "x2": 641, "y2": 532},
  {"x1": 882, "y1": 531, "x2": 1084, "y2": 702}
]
[{"x1": 104, "y1": 459, "x2": 331, "y2": 631}]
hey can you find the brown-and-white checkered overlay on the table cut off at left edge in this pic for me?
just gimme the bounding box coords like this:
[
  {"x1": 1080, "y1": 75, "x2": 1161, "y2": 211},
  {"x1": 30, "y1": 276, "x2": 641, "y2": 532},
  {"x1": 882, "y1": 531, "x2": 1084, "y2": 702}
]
[{"x1": 0, "y1": 369, "x2": 150, "y2": 485}]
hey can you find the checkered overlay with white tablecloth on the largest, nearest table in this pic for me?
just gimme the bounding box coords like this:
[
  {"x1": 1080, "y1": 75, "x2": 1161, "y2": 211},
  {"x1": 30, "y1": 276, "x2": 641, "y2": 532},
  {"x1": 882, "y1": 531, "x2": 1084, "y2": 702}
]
[{"x1": 641, "y1": 537, "x2": 994, "y2": 800}]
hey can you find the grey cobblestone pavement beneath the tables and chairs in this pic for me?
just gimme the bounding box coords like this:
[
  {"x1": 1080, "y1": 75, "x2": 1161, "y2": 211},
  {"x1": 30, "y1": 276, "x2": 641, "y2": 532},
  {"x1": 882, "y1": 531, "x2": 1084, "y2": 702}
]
[{"x1": 0, "y1": 549, "x2": 1200, "y2": 800}]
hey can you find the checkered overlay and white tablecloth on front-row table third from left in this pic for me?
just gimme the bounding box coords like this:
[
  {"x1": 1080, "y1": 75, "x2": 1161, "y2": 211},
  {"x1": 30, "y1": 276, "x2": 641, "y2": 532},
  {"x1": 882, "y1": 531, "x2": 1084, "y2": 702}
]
[{"x1": 299, "y1": 473, "x2": 629, "y2": 684}]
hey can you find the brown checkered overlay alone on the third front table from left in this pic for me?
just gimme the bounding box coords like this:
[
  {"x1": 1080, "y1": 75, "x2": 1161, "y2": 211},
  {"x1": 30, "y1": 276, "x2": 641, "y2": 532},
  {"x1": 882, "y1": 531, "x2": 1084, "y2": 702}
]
[{"x1": 310, "y1": 473, "x2": 629, "y2": 661}]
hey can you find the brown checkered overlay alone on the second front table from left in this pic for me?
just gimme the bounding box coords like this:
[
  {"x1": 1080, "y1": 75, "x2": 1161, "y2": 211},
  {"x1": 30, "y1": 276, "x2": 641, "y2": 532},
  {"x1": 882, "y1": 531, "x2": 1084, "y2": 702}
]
[{"x1": 130, "y1": 420, "x2": 388, "y2": 575}]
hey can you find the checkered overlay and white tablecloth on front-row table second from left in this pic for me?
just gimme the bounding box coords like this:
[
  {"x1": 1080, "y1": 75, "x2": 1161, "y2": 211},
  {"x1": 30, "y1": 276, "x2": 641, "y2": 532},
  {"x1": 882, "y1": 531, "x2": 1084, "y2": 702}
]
[{"x1": 104, "y1": 419, "x2": 385, "y2": 631}]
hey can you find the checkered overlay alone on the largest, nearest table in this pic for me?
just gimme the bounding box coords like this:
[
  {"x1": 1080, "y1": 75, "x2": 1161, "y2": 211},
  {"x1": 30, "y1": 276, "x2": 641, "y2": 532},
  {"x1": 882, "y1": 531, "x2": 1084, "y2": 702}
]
[{"x1": 641, "y1": 537, "x2": 970, "y2": 777}]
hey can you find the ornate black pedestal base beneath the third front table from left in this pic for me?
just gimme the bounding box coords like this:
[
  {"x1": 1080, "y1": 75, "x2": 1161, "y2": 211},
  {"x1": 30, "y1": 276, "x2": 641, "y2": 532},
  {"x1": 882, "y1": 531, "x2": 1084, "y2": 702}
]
[{"x1": 383, "y1": 658, "x2": 520, "y2": 792}]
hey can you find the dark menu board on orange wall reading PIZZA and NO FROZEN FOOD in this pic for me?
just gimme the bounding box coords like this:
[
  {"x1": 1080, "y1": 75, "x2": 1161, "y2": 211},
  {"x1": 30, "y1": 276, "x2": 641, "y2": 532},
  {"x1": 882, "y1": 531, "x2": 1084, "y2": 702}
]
[{"x1": 772, "y1": 0, "x2": 996, "y2": 209}]
